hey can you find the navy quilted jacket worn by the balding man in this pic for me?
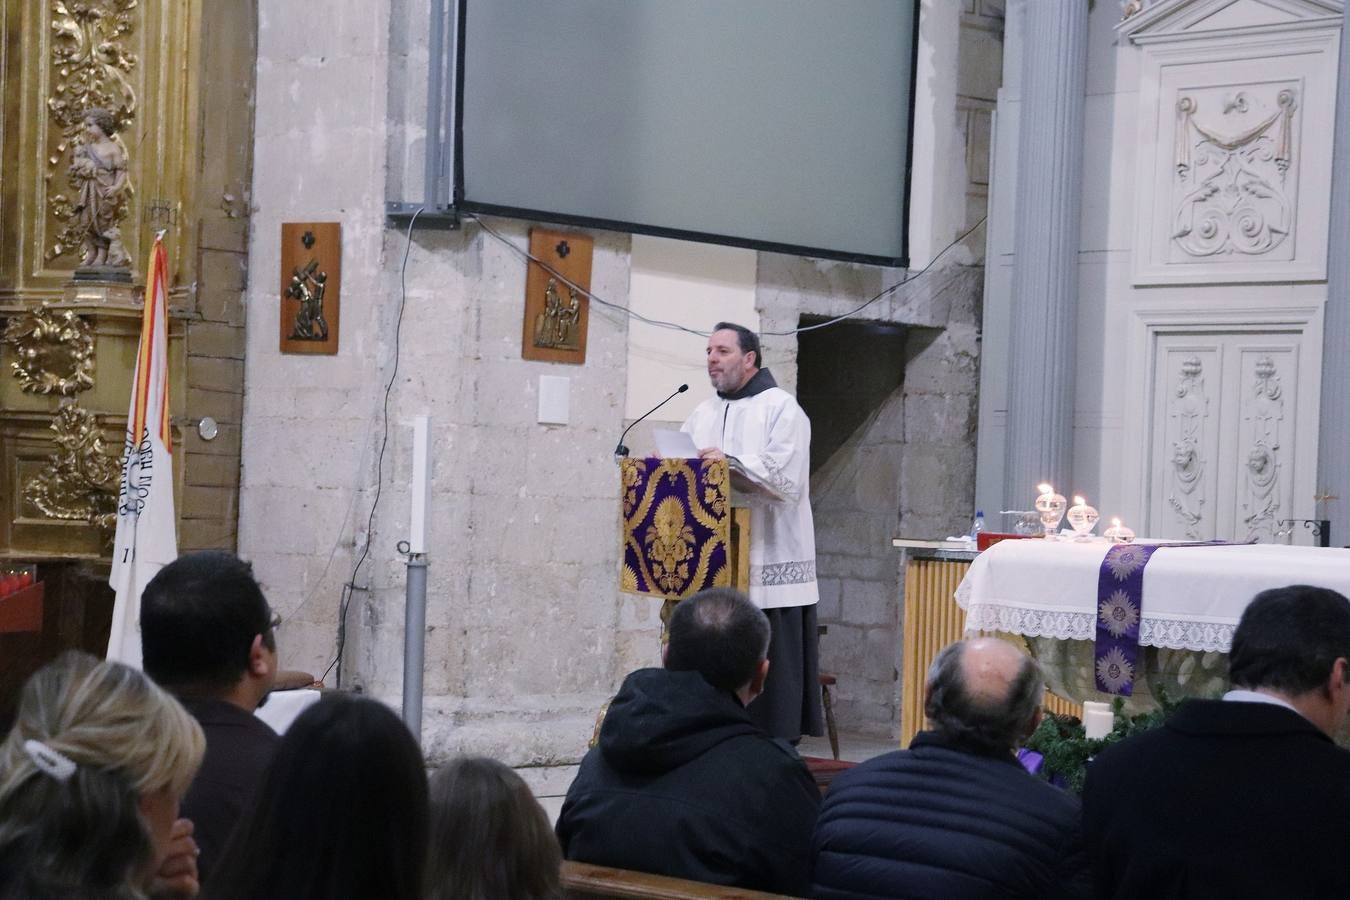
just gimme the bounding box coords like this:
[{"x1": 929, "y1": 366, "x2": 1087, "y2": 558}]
[{"x1": 811, "y1": 731, "x2": 1089, "y2": 900}]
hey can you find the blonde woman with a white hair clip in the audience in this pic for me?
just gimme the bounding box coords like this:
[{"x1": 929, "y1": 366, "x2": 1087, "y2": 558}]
[{"x1": 0, "y1": 653, "x2": 205, "y2": 900}]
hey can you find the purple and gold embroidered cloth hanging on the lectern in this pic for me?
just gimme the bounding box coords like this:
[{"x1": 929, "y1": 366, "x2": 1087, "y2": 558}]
[{"x1": 620, "y1": 457, "x2": 730, "y2": 600}]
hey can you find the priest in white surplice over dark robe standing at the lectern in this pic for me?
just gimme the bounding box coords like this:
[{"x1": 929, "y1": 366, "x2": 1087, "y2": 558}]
[{"x1": 682, "y1": 322, "x2": 824, "y2": 741}]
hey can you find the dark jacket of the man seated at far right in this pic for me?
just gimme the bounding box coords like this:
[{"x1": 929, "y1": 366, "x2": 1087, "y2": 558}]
[{"x1": 1083, "y1": 700, "x2": 1350, "y2": 897}]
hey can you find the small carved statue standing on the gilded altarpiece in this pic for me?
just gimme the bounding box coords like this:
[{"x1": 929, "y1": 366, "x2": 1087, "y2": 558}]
[{"x1": 69, "y1": 109, "x2": 132, "y2": 269}]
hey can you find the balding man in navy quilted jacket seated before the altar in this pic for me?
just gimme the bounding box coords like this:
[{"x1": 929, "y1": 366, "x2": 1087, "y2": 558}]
[{"x1": 811, "y1": 638, "x2": 1091, "y2": 900}]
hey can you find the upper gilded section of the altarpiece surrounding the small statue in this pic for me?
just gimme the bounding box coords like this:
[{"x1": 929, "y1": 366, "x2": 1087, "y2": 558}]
[{"x1": 0, "y1": 0, "x2": 200, "y2": 302}]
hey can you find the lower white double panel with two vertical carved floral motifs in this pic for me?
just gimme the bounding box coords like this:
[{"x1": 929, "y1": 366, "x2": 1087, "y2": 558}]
[{"x1": 1143, "y1": 316, "x2": 1318, "y2": 542}]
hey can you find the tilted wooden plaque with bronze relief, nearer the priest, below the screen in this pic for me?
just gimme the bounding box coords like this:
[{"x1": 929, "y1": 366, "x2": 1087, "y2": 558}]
[{"x1": 520, "y1": 228, "x2": 595, "y2": 366}]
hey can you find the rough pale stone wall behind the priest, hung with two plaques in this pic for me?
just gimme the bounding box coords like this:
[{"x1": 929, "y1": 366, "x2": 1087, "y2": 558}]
[{"x1": 239, "y1": 0, "x2": 999, "y2": 765}]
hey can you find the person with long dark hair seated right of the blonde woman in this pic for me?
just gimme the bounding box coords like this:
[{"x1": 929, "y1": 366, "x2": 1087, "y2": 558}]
[{"x1": 205, "y1": 694, "x2": 428, "y2": 900}]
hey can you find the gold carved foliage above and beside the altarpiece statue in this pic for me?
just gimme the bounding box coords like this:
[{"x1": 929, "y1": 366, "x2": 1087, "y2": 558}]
[{"x1": 43, "y1": 0, "x2": 139, "y2": 264}]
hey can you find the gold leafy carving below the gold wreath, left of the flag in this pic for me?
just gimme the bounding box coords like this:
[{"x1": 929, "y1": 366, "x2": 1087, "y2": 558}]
[{"x1": 23, "y1": 406, "x2": 122, "y2": 532}]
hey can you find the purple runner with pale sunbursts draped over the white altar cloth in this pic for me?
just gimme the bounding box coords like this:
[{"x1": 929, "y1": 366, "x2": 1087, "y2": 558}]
[{"x1": 1092, "y1": 541, "x2": 1229, "y2": 696}]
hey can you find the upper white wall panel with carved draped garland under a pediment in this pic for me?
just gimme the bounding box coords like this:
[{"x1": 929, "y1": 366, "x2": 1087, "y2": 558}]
[{"x1": 1123, "y1": 0, "x2": 1341, "y2": 285}]
